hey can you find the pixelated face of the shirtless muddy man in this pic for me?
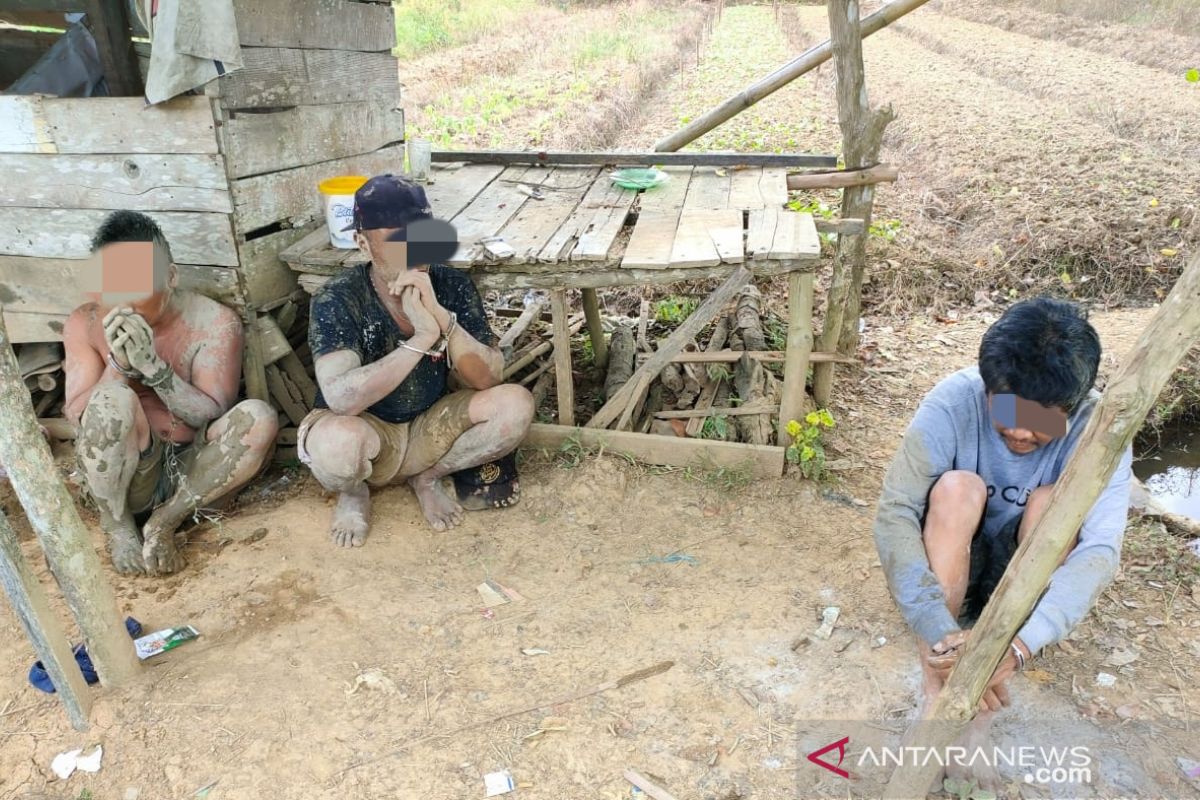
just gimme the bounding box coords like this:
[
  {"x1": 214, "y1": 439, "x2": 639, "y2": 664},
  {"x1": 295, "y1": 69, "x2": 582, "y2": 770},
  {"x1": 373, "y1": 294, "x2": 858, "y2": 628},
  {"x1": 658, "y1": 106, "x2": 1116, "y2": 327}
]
[{"x1": 83, "y1": 241, "x2": 175, "y2": 325}]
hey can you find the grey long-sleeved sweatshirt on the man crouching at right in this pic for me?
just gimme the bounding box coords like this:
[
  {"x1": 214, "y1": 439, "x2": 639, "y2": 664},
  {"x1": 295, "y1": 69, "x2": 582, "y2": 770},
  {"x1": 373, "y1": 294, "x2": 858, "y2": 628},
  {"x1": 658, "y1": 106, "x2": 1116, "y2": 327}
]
[{"x1": 875, "y1": 367, "x2": 1133, "y2": 652}]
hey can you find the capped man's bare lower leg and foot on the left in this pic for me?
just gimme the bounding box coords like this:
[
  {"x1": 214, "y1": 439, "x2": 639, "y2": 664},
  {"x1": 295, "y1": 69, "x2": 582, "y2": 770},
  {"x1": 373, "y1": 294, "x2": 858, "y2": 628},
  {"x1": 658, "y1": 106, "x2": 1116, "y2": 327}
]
[{"x1": 297, "y1": 415, "x2": 380, "y2": 547}]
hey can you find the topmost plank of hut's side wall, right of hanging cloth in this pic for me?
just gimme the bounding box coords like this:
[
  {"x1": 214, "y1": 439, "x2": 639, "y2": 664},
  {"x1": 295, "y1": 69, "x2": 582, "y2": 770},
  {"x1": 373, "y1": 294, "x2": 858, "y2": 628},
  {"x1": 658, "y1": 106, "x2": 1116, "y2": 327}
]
[{"x1": 234, "y1": 0, "x2": 396, "y2": 50}]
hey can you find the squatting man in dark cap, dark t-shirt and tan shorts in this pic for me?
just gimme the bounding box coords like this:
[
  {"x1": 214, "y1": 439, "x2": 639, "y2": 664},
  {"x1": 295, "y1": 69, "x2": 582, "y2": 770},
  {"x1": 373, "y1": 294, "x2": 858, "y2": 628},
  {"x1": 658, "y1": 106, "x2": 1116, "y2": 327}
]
[{"x1": 296, "y1": 175, "x2": 534, "y2": 547}]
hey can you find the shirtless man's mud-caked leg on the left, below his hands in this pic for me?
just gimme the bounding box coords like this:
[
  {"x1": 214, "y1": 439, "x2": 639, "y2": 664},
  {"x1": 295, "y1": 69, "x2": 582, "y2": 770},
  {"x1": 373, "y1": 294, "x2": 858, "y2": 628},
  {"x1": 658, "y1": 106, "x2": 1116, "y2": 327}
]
[{"x1": 76, "y1": 381, "x2": 150, "y2": 573}]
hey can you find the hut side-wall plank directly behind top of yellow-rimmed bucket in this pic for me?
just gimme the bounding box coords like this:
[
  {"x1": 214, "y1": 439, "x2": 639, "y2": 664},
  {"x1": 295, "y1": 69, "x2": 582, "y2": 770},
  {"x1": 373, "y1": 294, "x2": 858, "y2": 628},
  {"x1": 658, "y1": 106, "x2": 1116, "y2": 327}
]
[{"x1": 232, "y1": 146, "x2": 404, "y2": 235}]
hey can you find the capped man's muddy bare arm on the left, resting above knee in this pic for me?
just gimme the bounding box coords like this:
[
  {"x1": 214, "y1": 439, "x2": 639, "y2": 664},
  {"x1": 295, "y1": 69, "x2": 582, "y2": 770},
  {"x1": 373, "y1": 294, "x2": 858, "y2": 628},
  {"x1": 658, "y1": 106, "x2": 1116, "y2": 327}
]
[{"x1": 313, "y1": 337, "x2": 437, "y2": 416}]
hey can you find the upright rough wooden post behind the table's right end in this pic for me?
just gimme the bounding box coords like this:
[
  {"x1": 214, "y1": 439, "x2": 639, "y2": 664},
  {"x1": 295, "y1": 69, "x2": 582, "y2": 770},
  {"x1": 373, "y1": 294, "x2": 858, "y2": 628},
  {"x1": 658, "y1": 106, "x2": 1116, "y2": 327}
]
[{"x1": 812, "y1": 0, "x2": 895, "y2": 407}]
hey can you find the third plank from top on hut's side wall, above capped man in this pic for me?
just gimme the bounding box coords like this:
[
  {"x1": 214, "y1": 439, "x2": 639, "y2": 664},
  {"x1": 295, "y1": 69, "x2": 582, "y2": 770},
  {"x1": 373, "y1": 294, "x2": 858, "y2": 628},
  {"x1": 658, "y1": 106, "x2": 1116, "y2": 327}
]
[{"x1": 222, "y1": 101, "x2": 404, "y2": 178}]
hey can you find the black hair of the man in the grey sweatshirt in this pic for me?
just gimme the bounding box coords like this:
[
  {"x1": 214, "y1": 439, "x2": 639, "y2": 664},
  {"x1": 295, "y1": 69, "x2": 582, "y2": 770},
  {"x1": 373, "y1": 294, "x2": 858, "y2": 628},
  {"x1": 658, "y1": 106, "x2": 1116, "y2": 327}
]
[{"x1": 979, "y1": 297, "x2": 1100, "y2": 413}]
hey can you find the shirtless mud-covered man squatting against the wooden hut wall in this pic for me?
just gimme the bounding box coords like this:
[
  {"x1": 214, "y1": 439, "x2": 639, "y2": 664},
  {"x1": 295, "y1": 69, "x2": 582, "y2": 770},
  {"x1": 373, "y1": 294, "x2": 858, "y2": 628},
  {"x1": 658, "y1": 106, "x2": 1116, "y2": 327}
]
[{"x1": 62, "y1": 211, "x2": 278, "y2": 575}]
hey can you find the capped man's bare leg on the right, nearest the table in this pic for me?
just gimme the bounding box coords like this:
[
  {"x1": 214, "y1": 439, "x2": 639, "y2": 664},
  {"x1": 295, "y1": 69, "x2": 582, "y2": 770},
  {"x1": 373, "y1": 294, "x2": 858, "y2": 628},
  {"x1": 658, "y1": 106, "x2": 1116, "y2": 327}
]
[{"x1": 408, "y1": 384, "x2": 534, "y2": 530}]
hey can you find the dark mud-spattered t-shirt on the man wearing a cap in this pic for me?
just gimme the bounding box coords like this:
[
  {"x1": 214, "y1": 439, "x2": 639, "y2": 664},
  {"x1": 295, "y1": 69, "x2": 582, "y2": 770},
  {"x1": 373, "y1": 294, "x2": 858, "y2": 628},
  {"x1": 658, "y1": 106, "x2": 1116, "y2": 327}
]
[{"x1": 308, "y1": 264, "x2": 497, "y2": 422}]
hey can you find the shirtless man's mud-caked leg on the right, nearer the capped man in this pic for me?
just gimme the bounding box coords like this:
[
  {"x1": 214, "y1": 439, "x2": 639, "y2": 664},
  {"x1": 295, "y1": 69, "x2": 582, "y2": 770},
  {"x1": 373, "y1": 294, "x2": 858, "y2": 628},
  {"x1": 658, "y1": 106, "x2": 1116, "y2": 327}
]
[{"x1": 142, "y1": 399, "x2": 278, "y2": 575}]
